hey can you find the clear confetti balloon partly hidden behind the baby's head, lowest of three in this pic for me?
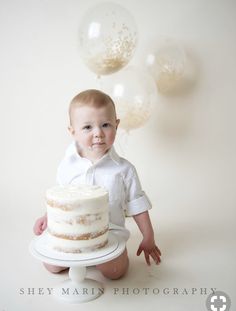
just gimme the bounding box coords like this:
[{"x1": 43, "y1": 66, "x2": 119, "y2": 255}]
[{"x1": 103, "y1": 66, "x2": 157, "y2": 131}]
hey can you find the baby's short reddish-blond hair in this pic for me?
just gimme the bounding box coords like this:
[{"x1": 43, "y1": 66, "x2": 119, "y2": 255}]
[{"x1": 69, "y1": 89, "x2": 116, "y2": 124}]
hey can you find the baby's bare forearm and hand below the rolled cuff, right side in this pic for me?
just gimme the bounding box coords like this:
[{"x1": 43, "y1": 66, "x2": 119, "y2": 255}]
[{"x1": 133, "y1": 211, "x2": 161, "y2": 265}]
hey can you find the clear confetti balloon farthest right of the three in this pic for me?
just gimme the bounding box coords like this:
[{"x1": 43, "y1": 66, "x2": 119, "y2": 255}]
[{"x1": 145, "y1": 39, "x2": 186, "y2": 93}]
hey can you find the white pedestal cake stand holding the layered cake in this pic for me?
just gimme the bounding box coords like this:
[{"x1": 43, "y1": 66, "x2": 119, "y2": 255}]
[{"x1": 29, "y1": 224, "x2": 129, "y2": 303}]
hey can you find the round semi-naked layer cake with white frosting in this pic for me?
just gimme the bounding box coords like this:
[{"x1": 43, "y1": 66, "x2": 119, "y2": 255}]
[{"x1": 46, "y1": 185, "x2": 109, "y2": 253}]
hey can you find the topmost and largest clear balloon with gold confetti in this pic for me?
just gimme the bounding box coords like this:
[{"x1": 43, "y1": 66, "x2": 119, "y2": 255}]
[{"x1": 79, "y1": 2, "x2": 138, "y2": 76}]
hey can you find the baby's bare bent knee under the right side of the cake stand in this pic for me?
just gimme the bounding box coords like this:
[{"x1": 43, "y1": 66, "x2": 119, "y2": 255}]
[{"x1": 96, "y1": 249, "x2": 129, "y2": 280}]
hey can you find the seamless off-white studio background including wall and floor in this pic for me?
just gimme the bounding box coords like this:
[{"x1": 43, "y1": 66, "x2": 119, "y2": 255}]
[{"x1": 0, "y1": 0, "x2": 236, "y2": 311}]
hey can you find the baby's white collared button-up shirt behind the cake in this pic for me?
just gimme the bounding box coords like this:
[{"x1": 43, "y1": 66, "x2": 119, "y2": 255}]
[{"x1": 57, "y1": 142, "x2": 151, "y2": 227}]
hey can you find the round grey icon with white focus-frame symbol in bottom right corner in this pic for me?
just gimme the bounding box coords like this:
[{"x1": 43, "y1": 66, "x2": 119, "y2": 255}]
[{"x1": 206, "y1": 291, "x2": 231, "y2": 311}]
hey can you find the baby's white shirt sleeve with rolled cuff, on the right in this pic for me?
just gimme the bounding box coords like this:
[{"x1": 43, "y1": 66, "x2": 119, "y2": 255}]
[{"x1": 125, "y1": 167, "x2": 152, "y2": 216}]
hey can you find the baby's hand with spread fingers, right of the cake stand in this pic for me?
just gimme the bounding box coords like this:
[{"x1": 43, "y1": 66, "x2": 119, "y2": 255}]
[{"x1": 137, "y1": 238, "x2": 161, "y2": 266}]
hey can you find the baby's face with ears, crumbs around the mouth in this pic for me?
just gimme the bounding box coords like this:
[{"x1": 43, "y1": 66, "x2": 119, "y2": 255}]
[{"x1": 69, "y1": 104, "x2": 119, "y2": 159}]
